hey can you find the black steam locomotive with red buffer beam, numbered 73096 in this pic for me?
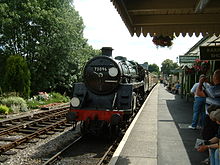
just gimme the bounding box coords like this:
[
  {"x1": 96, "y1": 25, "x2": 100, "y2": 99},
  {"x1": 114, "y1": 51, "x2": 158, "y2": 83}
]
[{"x1": 67, "y1": 47, "x2": 157, "y2": 135}]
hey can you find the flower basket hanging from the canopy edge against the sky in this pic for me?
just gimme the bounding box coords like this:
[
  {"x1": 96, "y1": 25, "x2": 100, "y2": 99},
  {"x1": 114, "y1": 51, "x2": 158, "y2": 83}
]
[{"x1": 152, "y1": 35, "x2": 174, "y2": 47}]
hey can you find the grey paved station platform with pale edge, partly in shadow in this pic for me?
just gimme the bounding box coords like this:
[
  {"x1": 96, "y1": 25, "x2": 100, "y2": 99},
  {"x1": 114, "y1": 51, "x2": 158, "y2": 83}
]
[{"x1": 109, "y1": 84, "x2": 208, "y2": 165}]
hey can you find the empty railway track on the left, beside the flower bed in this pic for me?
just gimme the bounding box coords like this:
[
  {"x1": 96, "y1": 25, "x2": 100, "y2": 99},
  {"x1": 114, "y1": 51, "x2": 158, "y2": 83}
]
[{"x1": 0, "y1": 106, "x2": 71, "y2": 161}]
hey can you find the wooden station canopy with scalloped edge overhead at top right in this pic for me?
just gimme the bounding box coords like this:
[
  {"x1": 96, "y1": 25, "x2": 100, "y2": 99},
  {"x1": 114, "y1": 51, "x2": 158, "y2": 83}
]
[{"x1": 111, "y1": 0, "x2": 220, "y2": 36}]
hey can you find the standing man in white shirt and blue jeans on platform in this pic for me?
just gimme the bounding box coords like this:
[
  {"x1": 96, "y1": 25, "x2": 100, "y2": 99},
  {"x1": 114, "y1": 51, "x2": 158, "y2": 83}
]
[{"x1": 188, "y1": 74, "x2": 209, "y2": 129}]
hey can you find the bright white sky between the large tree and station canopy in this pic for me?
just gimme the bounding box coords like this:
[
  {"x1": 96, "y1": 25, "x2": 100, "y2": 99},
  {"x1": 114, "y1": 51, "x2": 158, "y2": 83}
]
[{"x1": 73, "y1": 0, "x2": 202, "y2": 67}]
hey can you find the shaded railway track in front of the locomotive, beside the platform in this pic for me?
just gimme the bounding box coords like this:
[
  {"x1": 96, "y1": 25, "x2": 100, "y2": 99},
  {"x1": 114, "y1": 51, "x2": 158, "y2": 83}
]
[{"x1": 40, "y1": 105, "x2": 135, "y2": 165}]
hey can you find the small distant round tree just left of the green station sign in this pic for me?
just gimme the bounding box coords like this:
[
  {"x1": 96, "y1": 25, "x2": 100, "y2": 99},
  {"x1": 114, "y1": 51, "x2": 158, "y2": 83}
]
[{"x1": 161, "y1": 59, "x2": 178, "y2": 76}]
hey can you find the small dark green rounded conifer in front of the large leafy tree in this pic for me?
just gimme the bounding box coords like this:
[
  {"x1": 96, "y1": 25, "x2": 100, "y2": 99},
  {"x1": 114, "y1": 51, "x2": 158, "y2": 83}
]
[{"x1": 4, "y1": 55, "x2": 31, "y2": 98}]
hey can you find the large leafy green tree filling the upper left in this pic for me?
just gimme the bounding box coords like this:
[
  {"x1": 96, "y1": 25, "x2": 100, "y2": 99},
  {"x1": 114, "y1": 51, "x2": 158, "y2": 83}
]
[{"x1": 0, "y1": 0, "x2": 97, "y2": 93}]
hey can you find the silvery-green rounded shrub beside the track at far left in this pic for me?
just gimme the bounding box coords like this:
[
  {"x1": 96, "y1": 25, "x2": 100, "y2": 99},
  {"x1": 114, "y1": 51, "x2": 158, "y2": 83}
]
[{"x1": 1, "y1": 97, "x2": 28, "y2": 113}]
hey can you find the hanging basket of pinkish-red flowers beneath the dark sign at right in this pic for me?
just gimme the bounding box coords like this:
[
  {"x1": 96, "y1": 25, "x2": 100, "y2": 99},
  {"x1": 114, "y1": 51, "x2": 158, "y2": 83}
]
[{"x1": 193, "y1": 59, "x2": 210, "y2": 74}]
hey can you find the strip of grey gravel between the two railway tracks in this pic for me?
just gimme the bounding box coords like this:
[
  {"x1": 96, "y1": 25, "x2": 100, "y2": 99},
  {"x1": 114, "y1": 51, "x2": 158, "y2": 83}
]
[{"x1": 1, "y1": 127, "x2": 79, "y2": 165}]
